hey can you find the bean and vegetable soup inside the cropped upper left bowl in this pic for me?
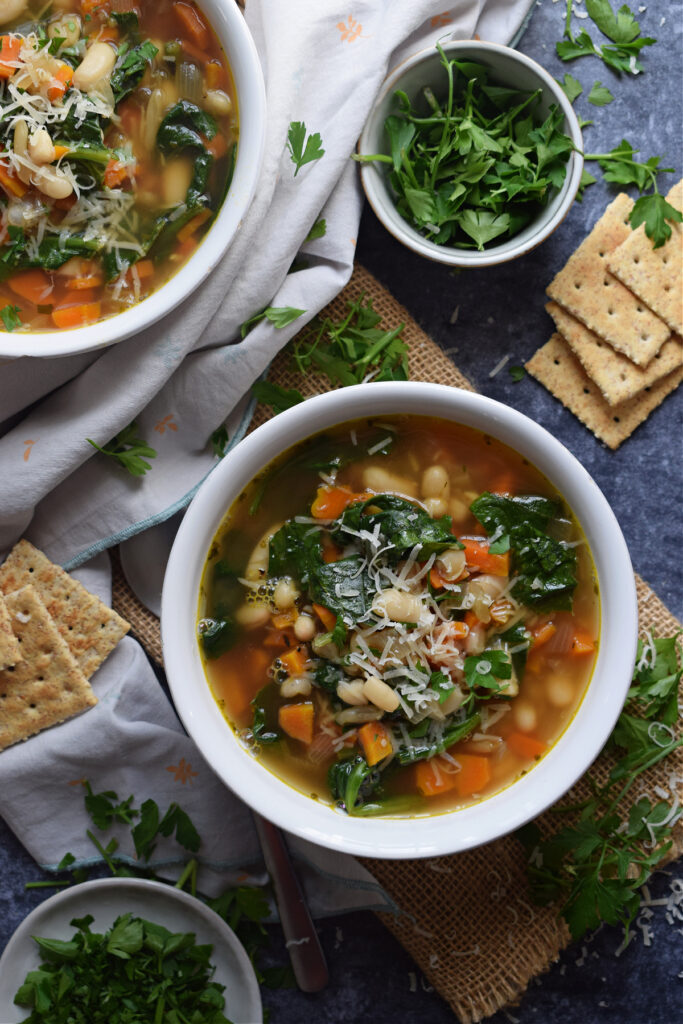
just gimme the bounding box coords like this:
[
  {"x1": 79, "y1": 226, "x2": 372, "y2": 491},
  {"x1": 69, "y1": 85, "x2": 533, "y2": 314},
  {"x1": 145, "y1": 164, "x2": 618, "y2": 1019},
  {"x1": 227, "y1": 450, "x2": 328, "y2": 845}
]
[{"x1": 0, "y1": 0, "x2": 238, "y2": 331}]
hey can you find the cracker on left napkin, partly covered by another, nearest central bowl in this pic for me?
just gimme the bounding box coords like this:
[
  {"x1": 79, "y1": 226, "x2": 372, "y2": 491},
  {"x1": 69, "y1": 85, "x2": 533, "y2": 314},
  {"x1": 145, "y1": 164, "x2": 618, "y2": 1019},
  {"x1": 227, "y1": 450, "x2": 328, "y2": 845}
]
[{"x1": 0, "y1": 541, "x2": 130, "y2": 679}]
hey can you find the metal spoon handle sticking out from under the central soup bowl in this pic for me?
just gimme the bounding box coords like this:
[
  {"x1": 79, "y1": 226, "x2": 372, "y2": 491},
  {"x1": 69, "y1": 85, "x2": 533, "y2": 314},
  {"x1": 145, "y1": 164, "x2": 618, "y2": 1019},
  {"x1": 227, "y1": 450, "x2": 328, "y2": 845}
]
[{"x1": 254, "y1": 814, "x2": 330, "y2": 992}]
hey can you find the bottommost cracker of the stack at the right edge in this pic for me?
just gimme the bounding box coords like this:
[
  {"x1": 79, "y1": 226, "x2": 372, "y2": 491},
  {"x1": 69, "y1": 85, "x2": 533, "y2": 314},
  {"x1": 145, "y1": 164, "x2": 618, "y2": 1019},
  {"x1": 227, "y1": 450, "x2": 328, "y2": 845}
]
[{"x1": 525, "y1": 334, "x2": 683, "y2": 449}]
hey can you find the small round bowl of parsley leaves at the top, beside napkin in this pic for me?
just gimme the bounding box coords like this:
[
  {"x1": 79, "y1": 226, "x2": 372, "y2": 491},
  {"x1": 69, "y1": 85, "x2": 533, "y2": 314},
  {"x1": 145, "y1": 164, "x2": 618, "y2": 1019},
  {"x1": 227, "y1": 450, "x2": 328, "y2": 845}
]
[{"x1": 355, "y1": 41, "x2": 583, "y2": 267}]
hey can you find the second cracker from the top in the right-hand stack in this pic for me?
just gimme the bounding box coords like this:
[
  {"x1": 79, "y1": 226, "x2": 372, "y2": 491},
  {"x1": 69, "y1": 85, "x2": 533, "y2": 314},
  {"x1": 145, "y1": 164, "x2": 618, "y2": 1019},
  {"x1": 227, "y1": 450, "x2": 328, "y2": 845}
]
[{"x1": 546, "y1": 195, "x2": 671, "y2": 367}]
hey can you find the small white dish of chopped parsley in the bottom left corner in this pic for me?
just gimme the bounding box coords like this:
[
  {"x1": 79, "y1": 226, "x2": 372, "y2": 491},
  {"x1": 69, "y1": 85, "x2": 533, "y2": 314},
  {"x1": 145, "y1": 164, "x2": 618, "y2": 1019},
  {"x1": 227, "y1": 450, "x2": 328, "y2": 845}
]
[{"x1": 0, "y1": 879, "x2": 262, "y2": 1024}]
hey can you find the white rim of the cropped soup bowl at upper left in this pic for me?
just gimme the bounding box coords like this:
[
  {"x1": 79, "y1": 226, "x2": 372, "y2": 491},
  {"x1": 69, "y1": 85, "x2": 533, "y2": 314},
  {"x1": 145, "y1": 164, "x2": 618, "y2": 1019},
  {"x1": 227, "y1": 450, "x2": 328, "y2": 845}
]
[{"x1": 0, "y1": 0, "x2": 265, "y2": 357}]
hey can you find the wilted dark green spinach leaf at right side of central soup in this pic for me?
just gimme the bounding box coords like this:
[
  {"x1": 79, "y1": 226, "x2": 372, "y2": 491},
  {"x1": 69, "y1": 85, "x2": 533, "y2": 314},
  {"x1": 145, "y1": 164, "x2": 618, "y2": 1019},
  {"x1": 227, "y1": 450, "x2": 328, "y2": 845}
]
[{"x1": 470, "y1": 492, "x2": 577, "y2": 609}]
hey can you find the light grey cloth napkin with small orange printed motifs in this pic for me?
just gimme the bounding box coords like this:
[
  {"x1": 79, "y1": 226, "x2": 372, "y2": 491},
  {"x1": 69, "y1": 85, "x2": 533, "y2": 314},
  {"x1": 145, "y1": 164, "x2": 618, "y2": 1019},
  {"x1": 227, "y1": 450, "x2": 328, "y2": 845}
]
[{"x1": 0, "y1": 0, "x2": 533, "y2": 914}]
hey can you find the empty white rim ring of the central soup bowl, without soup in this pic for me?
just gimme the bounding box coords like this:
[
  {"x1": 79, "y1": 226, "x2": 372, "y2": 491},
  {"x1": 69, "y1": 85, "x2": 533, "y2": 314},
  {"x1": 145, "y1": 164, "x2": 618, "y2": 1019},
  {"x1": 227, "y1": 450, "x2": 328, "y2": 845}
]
[{"x1": 162, "y1": 382, "x2": 637, "y2": 858}]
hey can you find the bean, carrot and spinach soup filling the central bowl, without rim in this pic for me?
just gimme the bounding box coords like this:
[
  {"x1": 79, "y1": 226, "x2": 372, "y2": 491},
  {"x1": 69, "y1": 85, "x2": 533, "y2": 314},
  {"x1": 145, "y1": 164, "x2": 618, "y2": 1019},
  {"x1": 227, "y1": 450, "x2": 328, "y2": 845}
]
[{"x1": 199, "y1": 416, "x2": 599, "y2": 816}]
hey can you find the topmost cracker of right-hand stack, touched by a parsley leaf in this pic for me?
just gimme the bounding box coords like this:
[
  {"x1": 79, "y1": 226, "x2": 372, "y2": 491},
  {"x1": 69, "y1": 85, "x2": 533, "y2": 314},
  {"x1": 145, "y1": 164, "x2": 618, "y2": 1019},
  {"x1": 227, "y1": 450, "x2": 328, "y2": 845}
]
[{"x1": 607, "y1": 179, "x2": 683, "y2": 334}]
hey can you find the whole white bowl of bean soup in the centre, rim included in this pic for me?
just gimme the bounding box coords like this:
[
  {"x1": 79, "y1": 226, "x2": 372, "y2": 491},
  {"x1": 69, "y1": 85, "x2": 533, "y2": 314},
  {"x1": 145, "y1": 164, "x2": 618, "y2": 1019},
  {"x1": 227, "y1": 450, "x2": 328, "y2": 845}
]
[{"x1": 162, "y1": 383, "x2": 636, "y2": 857}]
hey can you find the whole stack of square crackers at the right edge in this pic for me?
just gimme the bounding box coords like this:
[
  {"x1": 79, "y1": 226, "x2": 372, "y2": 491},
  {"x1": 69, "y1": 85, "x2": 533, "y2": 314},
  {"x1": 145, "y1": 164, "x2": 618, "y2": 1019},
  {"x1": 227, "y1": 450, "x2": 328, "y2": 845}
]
[{"x1": 526, "y1": 181, "x2": 683, "y2": 449}]
